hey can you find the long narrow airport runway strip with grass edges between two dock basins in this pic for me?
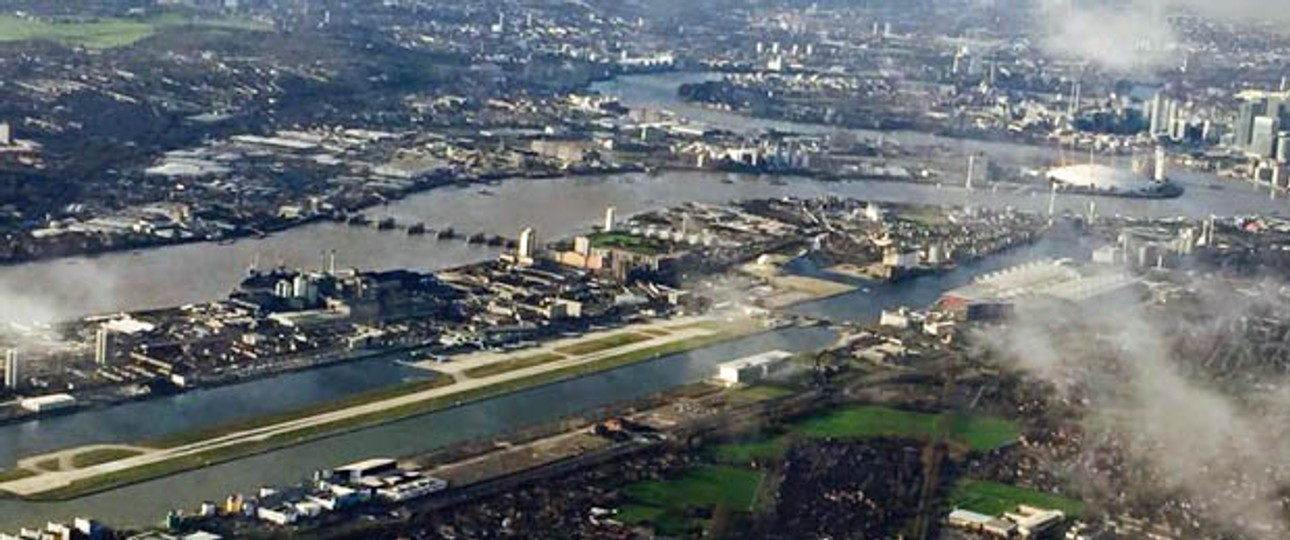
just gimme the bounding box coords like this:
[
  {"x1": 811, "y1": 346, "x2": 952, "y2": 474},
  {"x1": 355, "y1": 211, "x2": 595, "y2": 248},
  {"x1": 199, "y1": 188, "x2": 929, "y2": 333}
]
[{"x1": 0, "y1": 314, "x2": 766, "y2": 501}]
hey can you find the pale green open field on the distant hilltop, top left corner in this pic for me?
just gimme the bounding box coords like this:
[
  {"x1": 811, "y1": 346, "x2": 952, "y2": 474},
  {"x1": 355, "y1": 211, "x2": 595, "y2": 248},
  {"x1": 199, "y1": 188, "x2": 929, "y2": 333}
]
[{"x1": 0, "y1": 13, "x2": 268, "y2": 49}]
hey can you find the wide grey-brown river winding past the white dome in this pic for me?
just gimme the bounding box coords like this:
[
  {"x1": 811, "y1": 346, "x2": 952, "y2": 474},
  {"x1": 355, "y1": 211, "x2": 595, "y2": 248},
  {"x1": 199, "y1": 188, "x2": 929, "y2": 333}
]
[{"x1": 0, "y1": 73, "x2": 1286, "y2": 322}]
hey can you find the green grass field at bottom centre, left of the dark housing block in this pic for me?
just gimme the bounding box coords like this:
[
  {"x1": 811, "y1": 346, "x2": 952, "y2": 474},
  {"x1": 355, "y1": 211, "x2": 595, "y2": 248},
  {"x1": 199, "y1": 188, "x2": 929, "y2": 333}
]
[{"x1": 618, "y1": 465, "x2": 764, "y2": 535}]
